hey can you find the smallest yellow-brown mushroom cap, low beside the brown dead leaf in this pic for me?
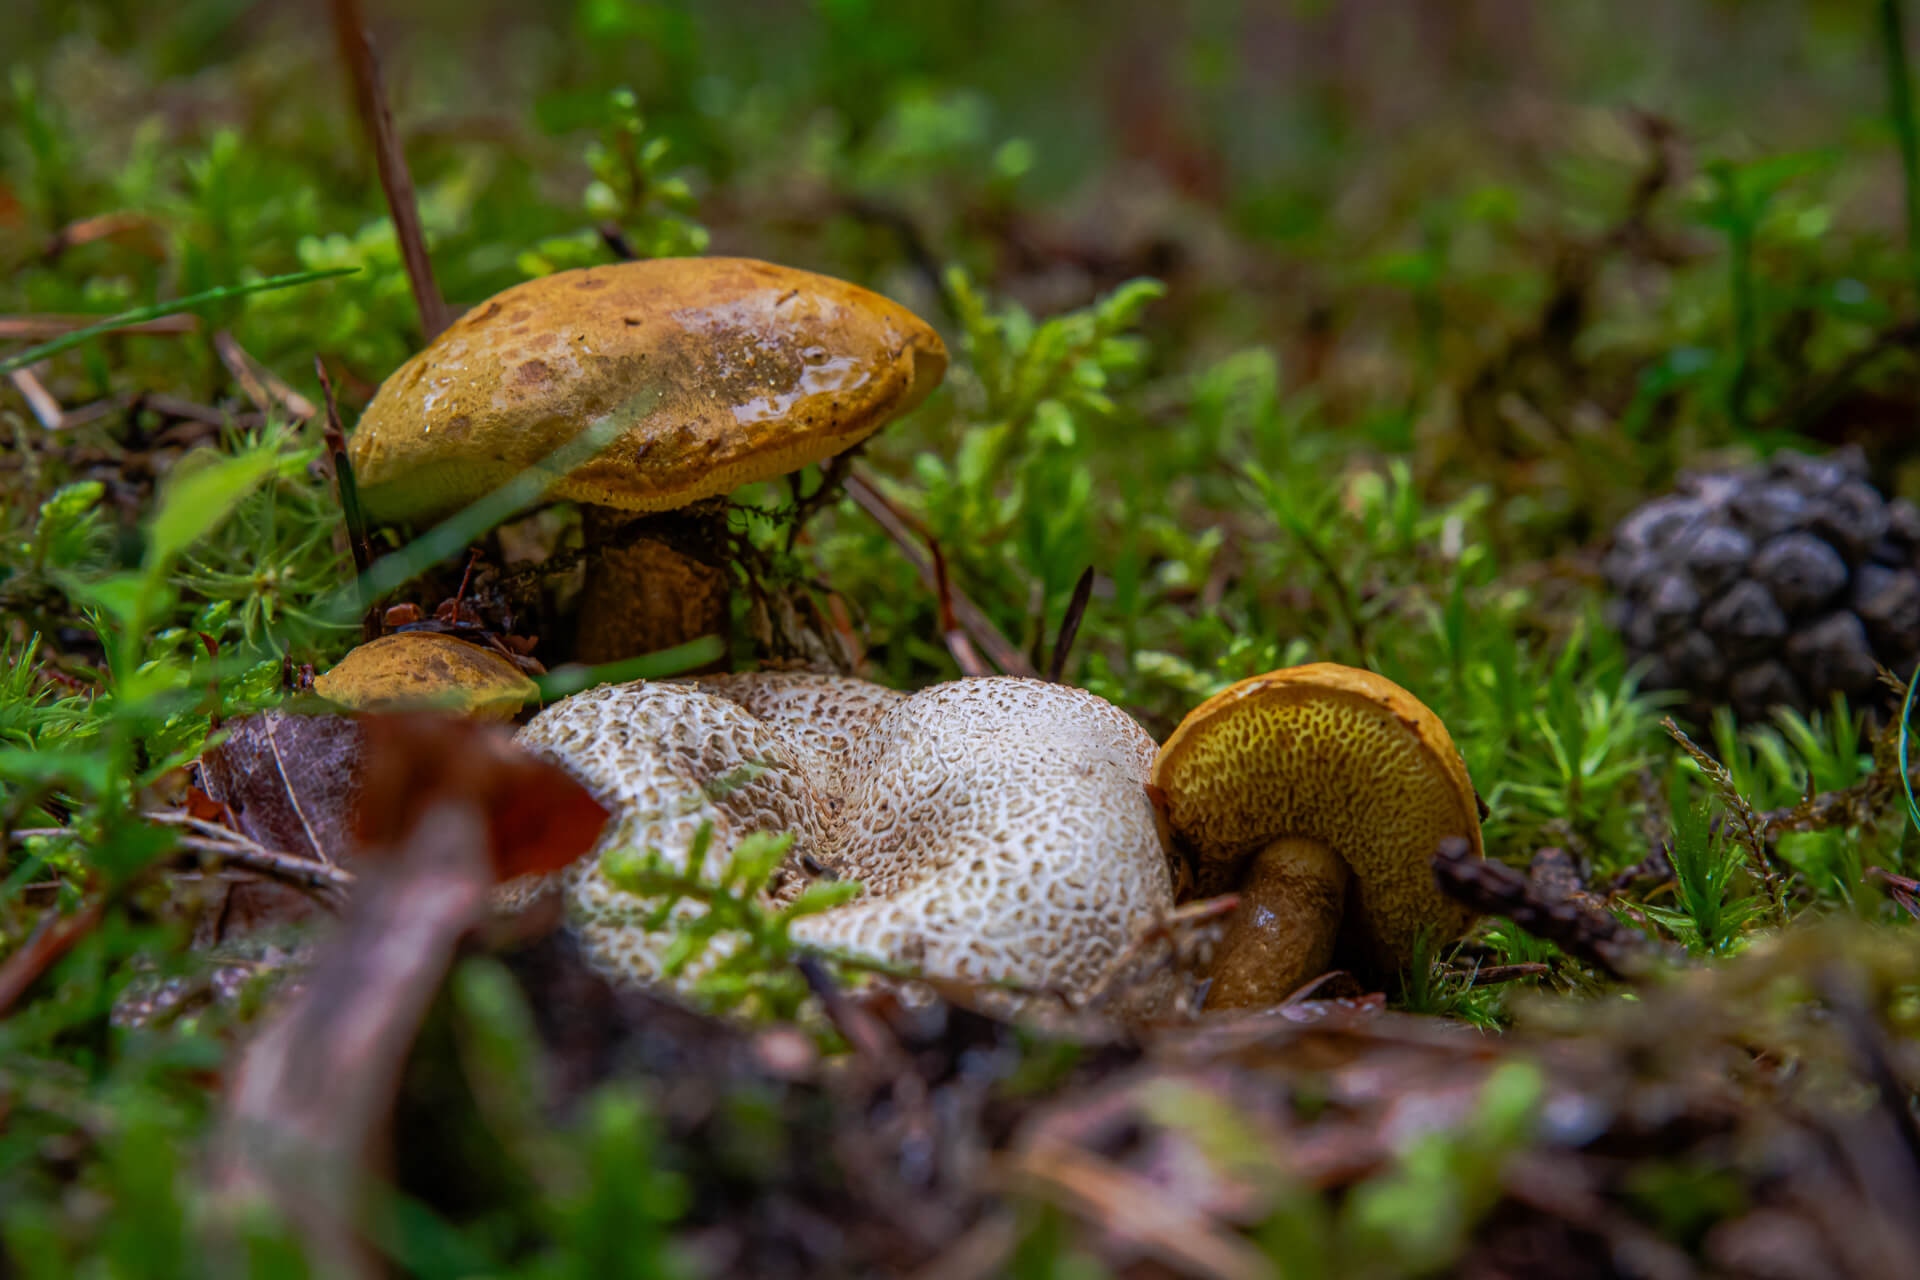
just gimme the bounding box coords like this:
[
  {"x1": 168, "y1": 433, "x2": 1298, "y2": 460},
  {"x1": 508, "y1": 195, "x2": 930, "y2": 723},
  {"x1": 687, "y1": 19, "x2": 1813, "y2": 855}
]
[{"x1": 313, "y1": 631, "x2": 540, "y2": 720}]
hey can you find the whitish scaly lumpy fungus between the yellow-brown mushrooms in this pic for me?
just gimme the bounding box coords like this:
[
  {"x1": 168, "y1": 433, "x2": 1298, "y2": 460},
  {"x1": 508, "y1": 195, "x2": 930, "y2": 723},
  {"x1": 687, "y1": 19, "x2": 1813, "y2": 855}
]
[{"x1": 520, "y1": 672, "x2": 1173, "y2": 996}]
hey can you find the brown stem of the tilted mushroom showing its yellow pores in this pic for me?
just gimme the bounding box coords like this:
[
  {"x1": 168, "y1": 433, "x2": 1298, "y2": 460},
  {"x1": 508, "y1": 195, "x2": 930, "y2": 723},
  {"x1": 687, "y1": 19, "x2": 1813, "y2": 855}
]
[{"x1": 1206, "y1": 835, "x2": 1352, "y2": 1009}]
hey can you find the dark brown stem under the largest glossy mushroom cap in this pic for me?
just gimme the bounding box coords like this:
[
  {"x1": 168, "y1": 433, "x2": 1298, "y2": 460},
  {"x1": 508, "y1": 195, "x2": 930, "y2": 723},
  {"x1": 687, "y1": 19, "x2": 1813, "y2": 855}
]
[{"x1": 574, "y1": 507, "x2": 733, "y2": 670}]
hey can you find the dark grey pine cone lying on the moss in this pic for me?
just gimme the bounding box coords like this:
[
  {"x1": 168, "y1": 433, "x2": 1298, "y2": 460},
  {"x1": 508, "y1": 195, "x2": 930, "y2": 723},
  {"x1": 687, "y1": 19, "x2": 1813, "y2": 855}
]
[{"x1": 1601, "y1": 449, "x2": 1920, "y2": 720}]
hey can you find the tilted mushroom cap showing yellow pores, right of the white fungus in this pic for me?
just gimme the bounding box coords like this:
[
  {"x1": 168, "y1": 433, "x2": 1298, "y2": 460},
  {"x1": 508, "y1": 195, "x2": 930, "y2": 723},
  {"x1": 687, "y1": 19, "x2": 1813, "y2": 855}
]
[{"x1": 1154, "y1": 662, "x2": 1482, "y2": 977}]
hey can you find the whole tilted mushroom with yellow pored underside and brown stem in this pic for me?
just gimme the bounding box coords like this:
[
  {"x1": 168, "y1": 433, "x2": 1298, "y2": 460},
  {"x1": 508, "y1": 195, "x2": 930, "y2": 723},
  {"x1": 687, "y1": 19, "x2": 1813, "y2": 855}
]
[{"x1": 1154, "y1": 662, "x2": 1482, "y2": 1009}]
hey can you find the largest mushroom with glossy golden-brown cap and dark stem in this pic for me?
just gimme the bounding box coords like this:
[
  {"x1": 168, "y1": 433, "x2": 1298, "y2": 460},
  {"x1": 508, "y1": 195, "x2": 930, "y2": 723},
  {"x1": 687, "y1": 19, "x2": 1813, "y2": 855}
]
[{"x1": 351, "y1": 257, "x2": 947, "y2": 662}]
